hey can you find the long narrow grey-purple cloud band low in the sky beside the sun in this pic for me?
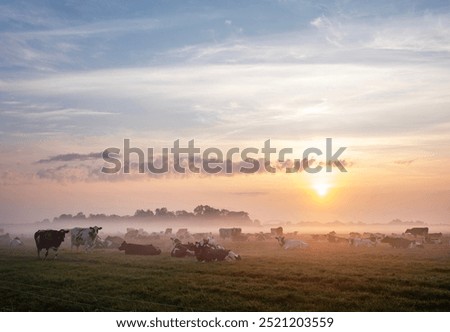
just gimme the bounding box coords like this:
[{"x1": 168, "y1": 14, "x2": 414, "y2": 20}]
[{"x1": 35, "y1": 153, "x2": 352, "y2": 183}]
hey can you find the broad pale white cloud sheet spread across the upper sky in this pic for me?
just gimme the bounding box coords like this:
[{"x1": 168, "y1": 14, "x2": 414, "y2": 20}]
[{"x1": 0, "y1": 3, "x2": 450, "y2": 171}]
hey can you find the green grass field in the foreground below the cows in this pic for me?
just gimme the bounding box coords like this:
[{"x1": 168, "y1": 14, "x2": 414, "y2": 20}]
[{"x1": 0, "y1": 241, "x2": 450, "y2": 311}]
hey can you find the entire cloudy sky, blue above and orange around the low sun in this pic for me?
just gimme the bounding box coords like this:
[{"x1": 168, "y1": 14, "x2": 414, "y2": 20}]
[{"x1": 0, "y1": 0, "x2": 450, "y2": 223}]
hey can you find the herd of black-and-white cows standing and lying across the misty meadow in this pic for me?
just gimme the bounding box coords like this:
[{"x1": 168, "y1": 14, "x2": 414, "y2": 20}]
[{"x1": 0, "y1": 226, "x2": 443, "y2": 262}]
